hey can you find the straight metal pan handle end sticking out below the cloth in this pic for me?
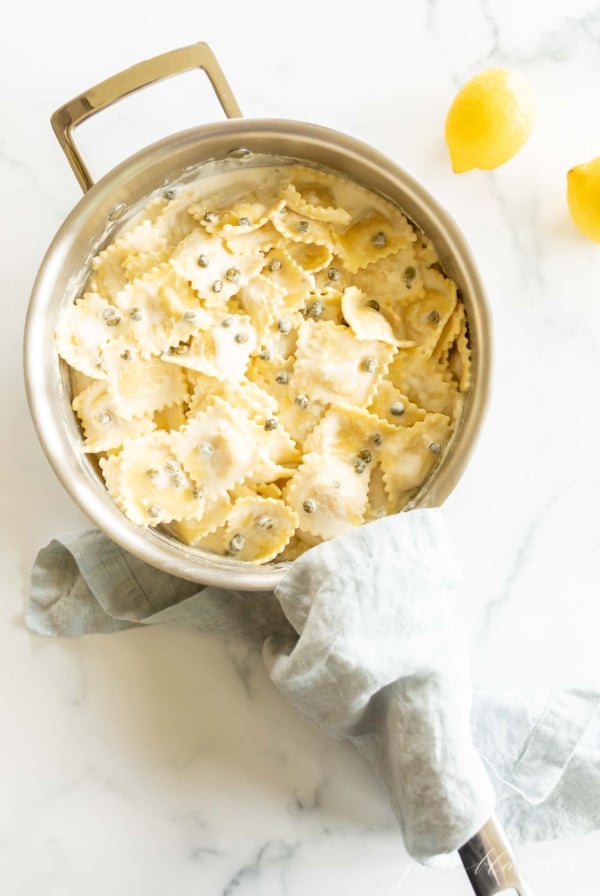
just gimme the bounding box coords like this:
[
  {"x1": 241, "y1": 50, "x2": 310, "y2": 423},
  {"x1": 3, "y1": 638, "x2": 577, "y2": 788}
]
[{"x1": 458, "y1": 816, "x2": 532, "y2": 896}]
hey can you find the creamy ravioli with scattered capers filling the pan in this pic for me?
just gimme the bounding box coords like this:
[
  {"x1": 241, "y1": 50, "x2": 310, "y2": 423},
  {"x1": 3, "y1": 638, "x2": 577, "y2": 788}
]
[{"x1": 55, "y1": 160, "x2": 471, "y2": 564}]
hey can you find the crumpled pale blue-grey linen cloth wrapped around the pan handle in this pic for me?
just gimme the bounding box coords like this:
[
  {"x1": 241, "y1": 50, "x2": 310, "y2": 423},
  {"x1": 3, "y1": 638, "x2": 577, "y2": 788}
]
[{"x1": 26, "y1": 509, "x2": 600, "y2": 861}]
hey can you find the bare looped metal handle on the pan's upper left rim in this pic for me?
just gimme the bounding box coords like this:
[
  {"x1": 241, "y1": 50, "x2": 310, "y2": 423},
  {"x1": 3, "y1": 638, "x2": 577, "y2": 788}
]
[{"x1": 50, "y1": 43, "x2": 242, "y2": 193}]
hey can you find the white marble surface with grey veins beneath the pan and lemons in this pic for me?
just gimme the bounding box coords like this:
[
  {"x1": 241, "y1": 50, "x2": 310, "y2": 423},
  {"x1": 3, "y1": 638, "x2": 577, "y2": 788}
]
[{"x1": 0, "y1": 0, "x2": 600, "y2": 896}]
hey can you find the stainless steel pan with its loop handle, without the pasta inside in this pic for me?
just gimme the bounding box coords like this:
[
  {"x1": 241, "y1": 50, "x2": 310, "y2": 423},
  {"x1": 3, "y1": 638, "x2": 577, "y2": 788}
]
[{"x1": 24, "y1": 43, "x2": 490, "y2": 591}]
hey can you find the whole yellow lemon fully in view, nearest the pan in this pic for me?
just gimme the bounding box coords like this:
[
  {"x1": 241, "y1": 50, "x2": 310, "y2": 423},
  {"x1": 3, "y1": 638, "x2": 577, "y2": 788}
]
[{"x1": 446, "y1": 68, "x2": 535, "y2": 174}]
